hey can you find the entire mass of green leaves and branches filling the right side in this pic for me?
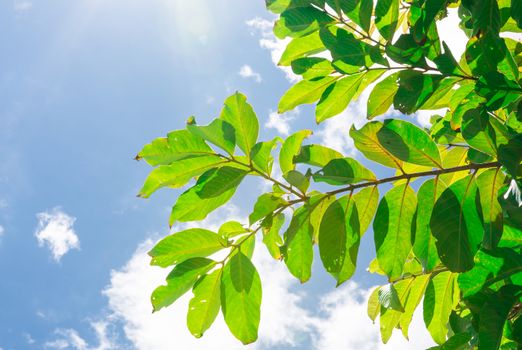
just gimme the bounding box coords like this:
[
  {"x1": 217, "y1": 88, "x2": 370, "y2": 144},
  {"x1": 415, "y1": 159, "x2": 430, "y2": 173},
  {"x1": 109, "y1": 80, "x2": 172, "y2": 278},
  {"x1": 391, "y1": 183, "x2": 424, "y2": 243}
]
[{"x1": 138, "y1": 0, "x2": 522, "y2": 350}]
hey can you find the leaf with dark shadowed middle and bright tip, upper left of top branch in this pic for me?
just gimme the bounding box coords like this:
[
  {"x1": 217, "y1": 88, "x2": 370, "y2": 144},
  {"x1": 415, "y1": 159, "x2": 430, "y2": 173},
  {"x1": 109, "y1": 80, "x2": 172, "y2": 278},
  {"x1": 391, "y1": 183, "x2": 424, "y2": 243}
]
[{"x1": 274, "y1": 7, "x2": 333, "y2": 39}]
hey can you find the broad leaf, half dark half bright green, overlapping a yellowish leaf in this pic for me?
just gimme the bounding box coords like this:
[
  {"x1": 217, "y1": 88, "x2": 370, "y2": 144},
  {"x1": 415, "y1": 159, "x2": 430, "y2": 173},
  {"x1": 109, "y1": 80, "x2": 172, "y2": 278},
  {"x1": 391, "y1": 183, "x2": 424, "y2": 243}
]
[{"x1": 377, "y1": 119, "x2": 442, "y2": 168}]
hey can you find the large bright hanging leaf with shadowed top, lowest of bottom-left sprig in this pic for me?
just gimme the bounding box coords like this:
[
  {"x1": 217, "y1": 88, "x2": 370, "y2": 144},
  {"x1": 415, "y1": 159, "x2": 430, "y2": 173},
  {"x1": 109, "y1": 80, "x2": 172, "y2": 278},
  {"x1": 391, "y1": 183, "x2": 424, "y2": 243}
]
[{"x1": 221, "y1": 252, "x2": 261, "y2": 344}]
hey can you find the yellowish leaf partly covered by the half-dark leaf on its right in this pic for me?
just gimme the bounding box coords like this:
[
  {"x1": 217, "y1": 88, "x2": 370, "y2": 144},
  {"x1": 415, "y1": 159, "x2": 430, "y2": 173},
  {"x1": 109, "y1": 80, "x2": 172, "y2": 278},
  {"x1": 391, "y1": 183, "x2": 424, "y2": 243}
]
[{"x1": 350, "y1": 122, "x2": 402, "y2": 169}]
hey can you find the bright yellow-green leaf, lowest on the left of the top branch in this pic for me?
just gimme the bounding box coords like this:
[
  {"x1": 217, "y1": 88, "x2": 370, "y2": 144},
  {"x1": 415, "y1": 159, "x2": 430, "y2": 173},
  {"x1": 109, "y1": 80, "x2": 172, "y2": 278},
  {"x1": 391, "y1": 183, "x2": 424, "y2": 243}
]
[{"x1": 278, "y1": 76, "x2": 339, "y2": 114}]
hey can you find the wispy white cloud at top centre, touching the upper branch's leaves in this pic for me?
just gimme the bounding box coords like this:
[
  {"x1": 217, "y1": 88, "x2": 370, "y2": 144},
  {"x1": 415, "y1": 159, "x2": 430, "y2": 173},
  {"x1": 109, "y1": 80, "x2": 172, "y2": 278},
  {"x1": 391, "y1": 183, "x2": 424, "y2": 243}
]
[{"x1": 246, "y1": 17, "x2": 300, "y2": 82}]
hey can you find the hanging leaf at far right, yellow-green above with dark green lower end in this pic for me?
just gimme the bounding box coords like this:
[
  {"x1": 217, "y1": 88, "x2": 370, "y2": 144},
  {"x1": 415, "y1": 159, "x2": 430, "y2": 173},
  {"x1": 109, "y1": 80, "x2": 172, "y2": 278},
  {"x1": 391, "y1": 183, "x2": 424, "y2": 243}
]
[{"x1": 477, "y1": 168, "x2": 505, "y2": 249}]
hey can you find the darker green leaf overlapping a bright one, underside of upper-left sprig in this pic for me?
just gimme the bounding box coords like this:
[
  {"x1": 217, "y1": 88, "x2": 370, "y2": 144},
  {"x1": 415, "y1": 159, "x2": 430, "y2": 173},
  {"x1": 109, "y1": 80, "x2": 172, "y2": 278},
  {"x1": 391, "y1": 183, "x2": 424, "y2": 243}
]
[{"x1": 196, "y1": 166, "x2": 248, "y2": 199}]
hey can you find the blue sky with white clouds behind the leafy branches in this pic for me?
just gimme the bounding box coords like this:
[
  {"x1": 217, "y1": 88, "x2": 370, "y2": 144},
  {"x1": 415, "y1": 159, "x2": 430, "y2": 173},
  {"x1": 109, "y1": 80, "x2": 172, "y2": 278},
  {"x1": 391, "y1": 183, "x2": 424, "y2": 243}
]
[{"x1": 0, "y1": 0, "x2": 452, "y2": 350}]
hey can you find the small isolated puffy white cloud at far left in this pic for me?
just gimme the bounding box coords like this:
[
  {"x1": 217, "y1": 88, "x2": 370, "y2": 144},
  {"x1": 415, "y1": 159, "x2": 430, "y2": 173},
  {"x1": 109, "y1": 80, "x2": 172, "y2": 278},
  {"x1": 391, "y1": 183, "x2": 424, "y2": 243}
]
[{"x1": 35, "y1": 208, "x2": 80, "y2": 262}]
